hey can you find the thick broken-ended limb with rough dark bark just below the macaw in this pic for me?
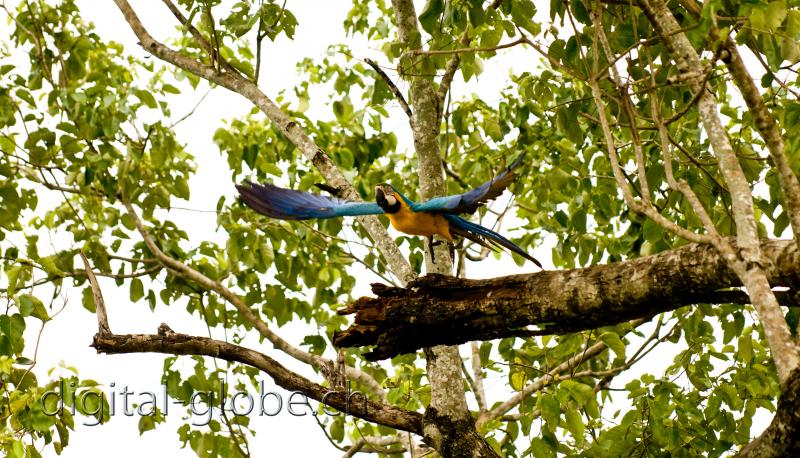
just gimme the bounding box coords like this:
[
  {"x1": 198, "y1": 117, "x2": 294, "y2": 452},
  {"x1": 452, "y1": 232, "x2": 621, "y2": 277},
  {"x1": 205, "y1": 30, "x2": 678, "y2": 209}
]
[{"x1": 334, "y1": 240, "x2": 800, "y2": 360}]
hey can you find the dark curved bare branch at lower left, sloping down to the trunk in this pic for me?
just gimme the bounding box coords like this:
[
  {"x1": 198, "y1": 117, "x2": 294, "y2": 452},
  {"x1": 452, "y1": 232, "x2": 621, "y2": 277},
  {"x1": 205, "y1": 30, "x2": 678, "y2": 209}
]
[{"x1": 92, "y1": 326, "x2": 422, "y2": 434}]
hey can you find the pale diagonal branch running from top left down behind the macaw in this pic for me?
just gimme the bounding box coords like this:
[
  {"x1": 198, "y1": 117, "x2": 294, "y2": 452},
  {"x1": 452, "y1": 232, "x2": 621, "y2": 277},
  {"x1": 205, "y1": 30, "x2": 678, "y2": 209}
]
[{"x1": 115, "y1": 0, "x2": 415, "y2": 283}]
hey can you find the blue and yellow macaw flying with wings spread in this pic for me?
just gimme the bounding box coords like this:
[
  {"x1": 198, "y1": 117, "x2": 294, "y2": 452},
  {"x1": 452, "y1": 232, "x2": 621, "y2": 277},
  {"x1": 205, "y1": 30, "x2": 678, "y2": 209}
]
[{"x1": 236, "y1": 154, "x2": 542, "y2": 268}]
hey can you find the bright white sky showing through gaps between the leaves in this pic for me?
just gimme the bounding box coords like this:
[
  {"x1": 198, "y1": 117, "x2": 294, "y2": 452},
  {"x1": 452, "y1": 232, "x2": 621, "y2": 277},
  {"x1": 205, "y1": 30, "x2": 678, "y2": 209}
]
[{"x1": 0, "y1": 0, "x2": 769, "y2": 458}]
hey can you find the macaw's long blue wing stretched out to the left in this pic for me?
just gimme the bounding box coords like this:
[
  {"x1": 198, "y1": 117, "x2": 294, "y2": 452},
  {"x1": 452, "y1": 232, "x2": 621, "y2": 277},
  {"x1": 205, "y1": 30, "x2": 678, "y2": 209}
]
[{"x1": 236, "y1": 181, "x2": 383, "y2": 220}]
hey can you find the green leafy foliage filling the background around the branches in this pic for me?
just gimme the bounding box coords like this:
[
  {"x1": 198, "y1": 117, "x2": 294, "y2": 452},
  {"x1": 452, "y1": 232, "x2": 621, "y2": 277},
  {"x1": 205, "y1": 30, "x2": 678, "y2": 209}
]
[{"x1": 0, "y1": 0, "x2": 800, "y2": 457}]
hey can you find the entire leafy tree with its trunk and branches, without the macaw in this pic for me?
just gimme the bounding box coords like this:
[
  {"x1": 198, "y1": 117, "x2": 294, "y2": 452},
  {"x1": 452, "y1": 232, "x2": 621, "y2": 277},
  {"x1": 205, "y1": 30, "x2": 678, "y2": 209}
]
[{"x1": 0, "y1": 0, "x2": 800, "y2": 458}]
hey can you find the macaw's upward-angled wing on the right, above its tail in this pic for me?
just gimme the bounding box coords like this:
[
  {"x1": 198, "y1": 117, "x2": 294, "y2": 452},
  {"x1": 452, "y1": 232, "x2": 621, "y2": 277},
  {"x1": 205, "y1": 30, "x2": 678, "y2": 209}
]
[{"x1": 411, "y1": 153, "x2": 525, "y2": 214}]
